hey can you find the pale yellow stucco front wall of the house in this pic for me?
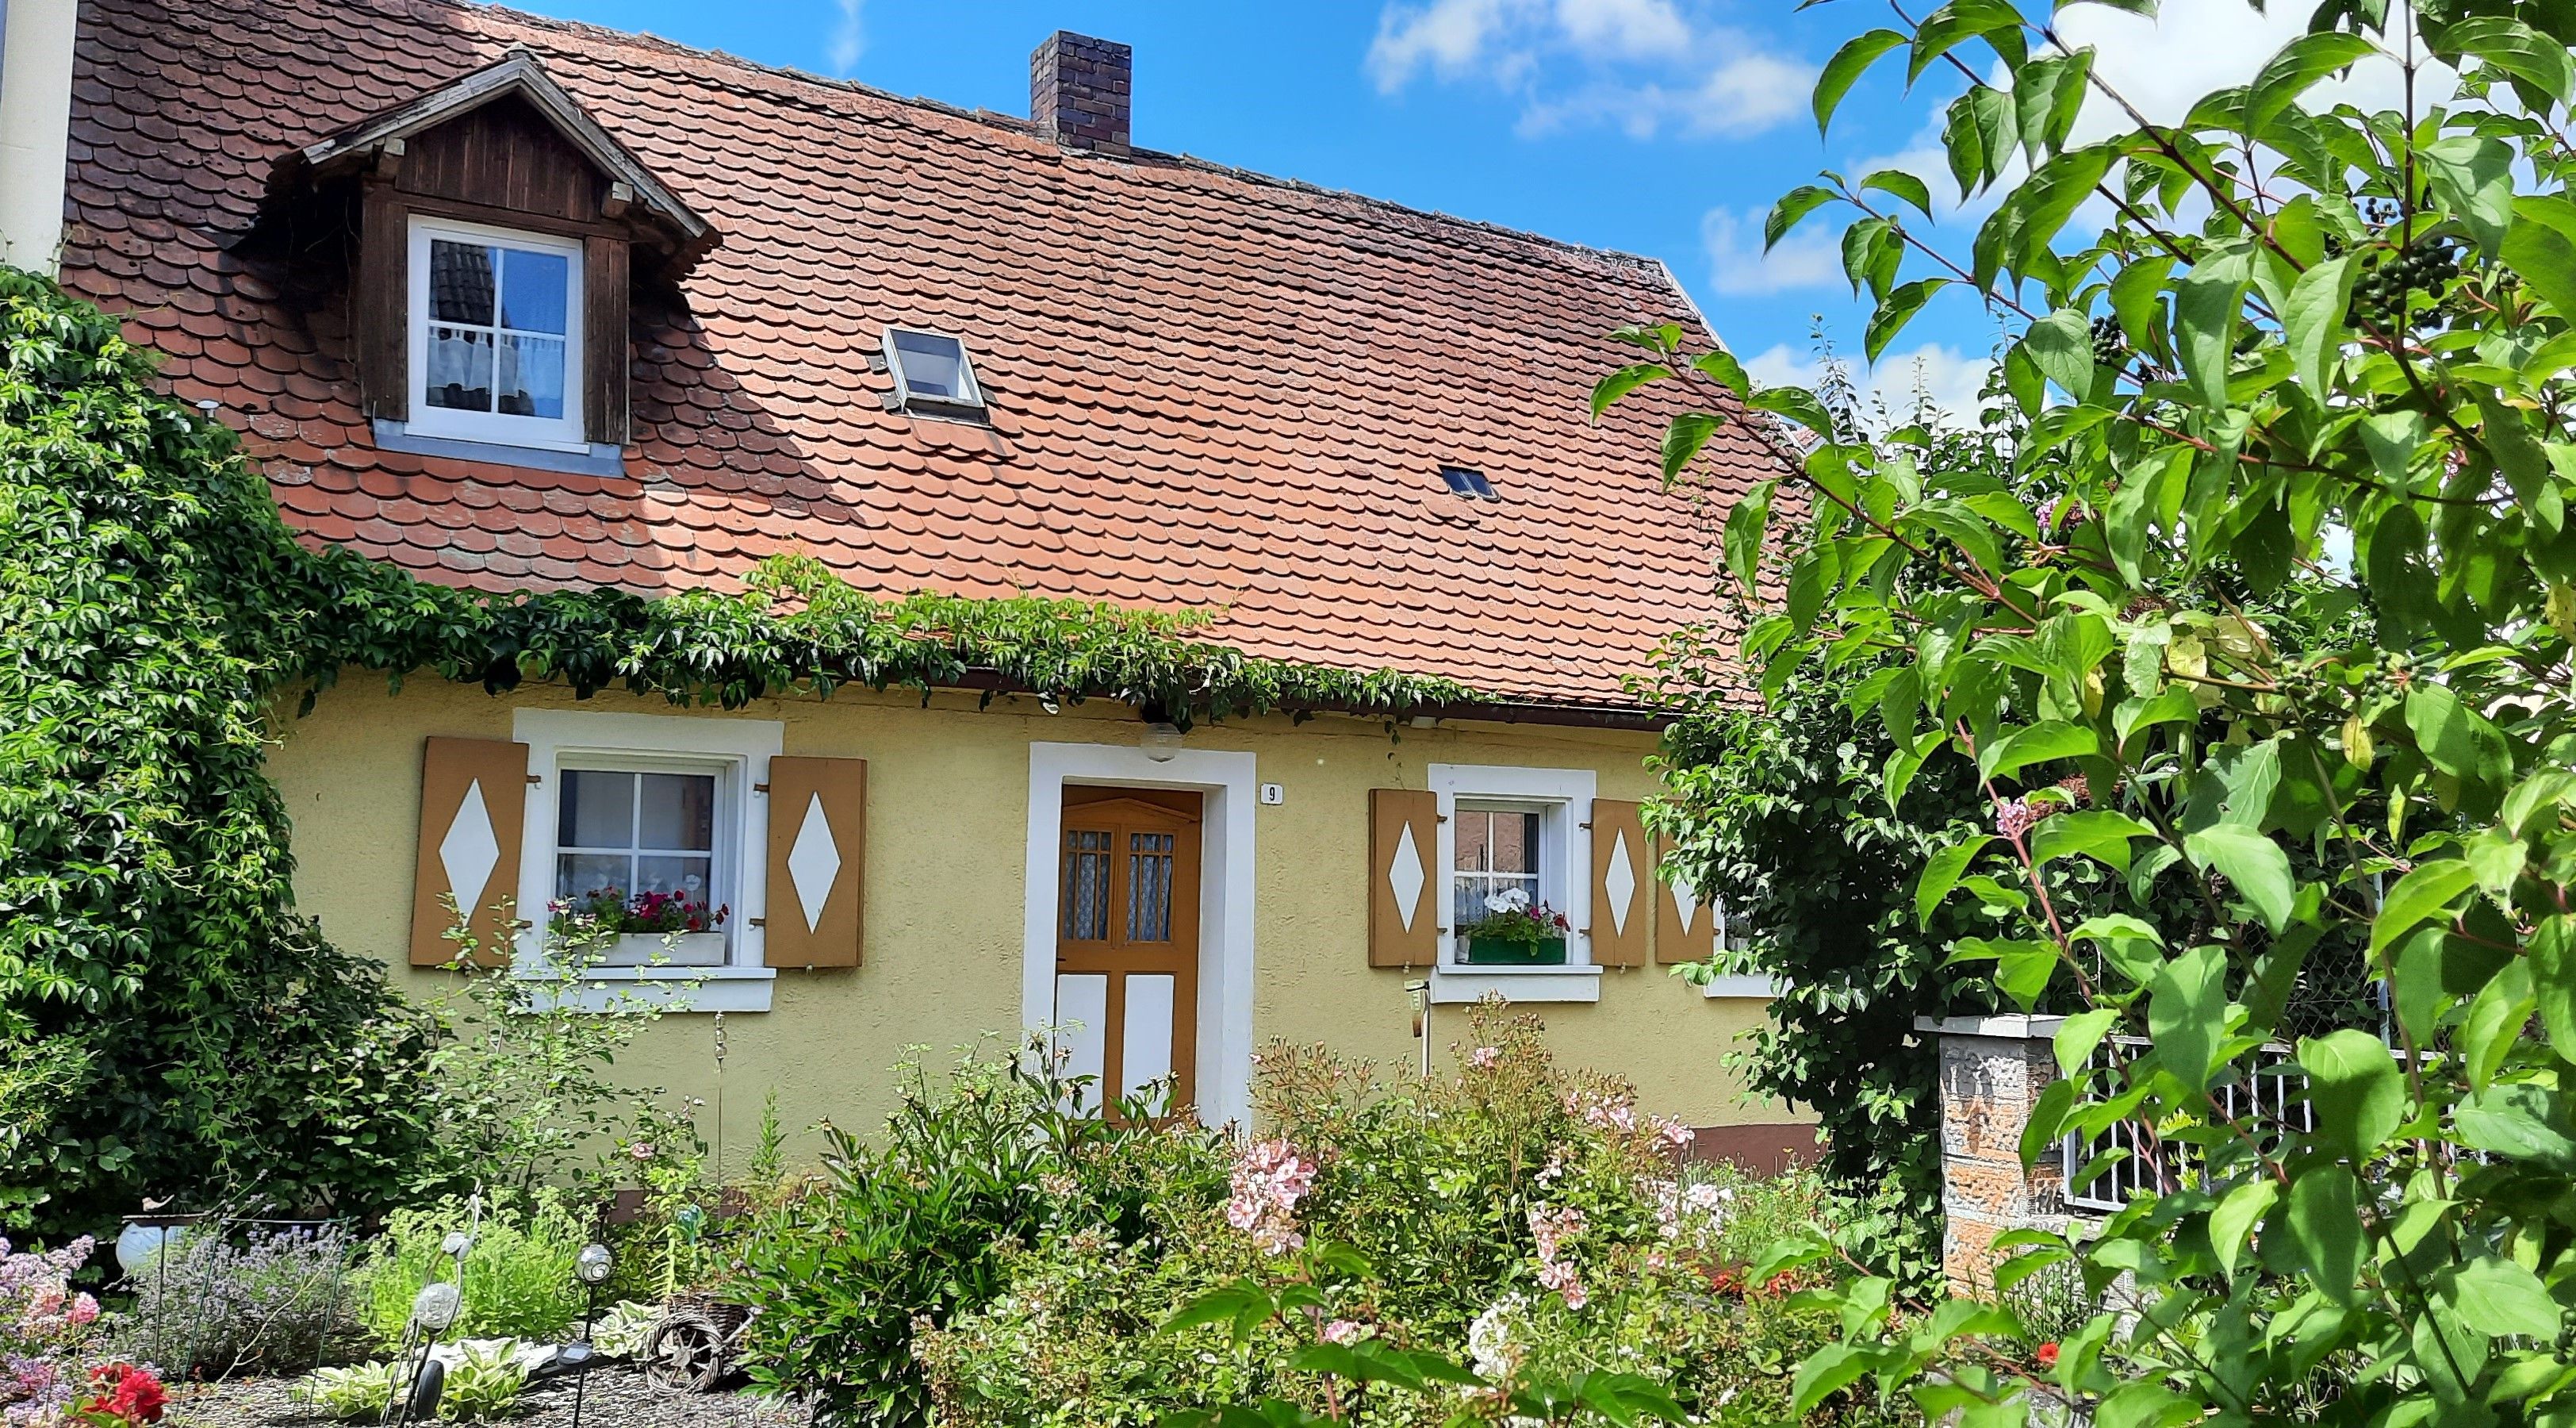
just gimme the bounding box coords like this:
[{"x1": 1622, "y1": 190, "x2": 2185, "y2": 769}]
[{"x1": 256, "y1": 673, "x2": 1806, "y2": 1157}]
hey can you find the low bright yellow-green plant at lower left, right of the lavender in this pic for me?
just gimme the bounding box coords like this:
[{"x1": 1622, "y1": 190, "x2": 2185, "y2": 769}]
[{"x1": 355, "y1": 1191, "x2": 590, "y2": 1348}]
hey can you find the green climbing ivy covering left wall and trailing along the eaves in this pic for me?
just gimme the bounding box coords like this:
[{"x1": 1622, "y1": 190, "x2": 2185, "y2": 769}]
[{"x1": 0, "y1": 268, "x2": 1476, "y2": 1230}]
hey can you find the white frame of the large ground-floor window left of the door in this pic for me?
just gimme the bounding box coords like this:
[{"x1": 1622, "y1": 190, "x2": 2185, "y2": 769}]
[{"x1": 510, "y1": 709, "x2": 786, "y2": 1011}]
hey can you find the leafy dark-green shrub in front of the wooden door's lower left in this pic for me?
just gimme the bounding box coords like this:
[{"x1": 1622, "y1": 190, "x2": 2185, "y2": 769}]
[{"x1": 729, "y1": 1044, "x2": 1224, "y2": 1428}]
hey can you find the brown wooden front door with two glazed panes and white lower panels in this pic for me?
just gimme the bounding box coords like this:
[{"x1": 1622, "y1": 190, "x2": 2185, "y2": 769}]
[{"x1": 1056, "y1": 789, "x2": 1201, "y2": 1114}]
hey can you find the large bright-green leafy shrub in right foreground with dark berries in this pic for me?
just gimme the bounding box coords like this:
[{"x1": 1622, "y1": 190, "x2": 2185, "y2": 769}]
[{"x1": 1605, "y1": 0, "x2": 2576, "y2": 1426}]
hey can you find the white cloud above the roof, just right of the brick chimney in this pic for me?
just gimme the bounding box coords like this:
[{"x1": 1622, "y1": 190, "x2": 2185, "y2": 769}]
[{"x1": 1368, "y1": 0, "x2": 1816, "y2": 139}]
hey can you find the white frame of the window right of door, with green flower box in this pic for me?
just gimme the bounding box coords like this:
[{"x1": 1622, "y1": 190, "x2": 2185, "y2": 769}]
[{"x1": 1427, "y1": 763, "x2": 1602, "y2": 1005}]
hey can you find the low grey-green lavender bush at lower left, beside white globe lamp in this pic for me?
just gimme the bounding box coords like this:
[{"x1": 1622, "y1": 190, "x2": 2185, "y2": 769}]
[{"x1": 116, "y1": 1224, "x2": 353, "y2": 1379}]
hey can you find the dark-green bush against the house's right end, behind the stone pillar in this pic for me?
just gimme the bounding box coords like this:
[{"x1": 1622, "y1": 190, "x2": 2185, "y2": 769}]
[{"x1": 1646, "y1": 637, "x2": 1996, "y2": 1279}]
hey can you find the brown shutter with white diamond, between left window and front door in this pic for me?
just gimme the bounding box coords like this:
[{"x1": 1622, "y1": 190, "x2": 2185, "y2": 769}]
[{"x1": 762, "y1": 758, "x2": 868, "y2": 966}]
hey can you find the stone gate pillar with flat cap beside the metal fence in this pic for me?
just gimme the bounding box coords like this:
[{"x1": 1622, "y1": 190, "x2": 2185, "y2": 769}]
[{"x1": 1914, "y1": 1015, "x2": 2068, "y2": 1294}]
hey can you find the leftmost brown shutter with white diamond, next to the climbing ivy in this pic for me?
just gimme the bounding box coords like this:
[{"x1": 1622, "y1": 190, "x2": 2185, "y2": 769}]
[{"x1": 412, "y1": 737, "x2": 527, "y2": 966}]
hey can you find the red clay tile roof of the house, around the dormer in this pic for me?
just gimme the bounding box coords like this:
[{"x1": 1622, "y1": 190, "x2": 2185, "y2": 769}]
[{"x1": 64, "y1": 0, "x2": 1780, "y2": 706}]
